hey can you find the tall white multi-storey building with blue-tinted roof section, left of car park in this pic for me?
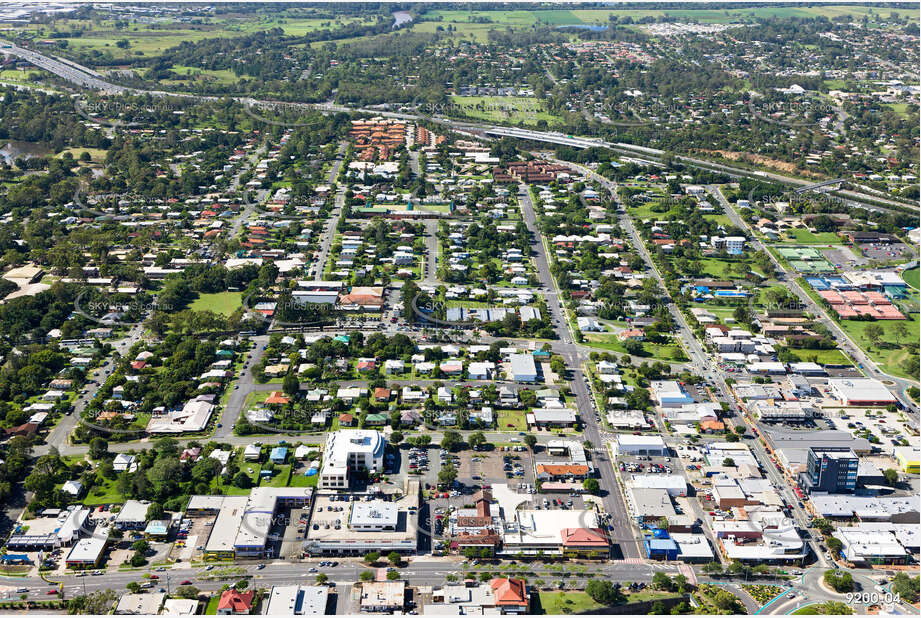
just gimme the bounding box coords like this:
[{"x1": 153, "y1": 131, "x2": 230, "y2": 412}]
[{"x1": 319, "y1": 429, "x2": 387, "y2": 489}]
